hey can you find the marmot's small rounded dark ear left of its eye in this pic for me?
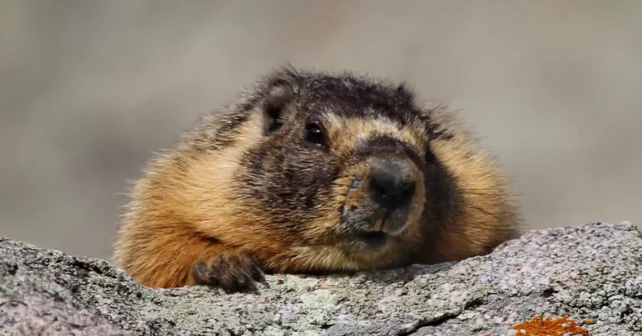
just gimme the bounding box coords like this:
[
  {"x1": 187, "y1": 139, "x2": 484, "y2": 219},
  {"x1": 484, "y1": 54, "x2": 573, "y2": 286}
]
[{"x1": 263, "y1": 80, "x2": 294, "y2": 135}]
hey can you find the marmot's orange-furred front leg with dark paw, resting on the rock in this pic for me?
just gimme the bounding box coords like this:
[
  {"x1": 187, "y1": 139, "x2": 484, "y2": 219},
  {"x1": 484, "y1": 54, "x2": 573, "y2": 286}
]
[{"x1": 118, "y1": 229, "x2": 265, "y2": 293}]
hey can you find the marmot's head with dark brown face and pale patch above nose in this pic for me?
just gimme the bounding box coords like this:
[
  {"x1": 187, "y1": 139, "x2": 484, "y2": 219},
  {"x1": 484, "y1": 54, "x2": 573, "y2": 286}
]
[{"x1": 180, "y1": 69, "x2": 458, "y2": 255}]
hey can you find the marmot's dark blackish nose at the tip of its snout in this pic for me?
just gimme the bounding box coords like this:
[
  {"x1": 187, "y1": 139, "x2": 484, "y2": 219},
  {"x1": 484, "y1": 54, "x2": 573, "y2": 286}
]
[{"x1": 368, "y1": 159, "x2": 415, "y2": 210}]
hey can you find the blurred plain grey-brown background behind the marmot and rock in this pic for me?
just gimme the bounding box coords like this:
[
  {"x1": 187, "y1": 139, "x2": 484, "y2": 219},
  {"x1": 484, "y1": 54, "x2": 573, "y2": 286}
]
[{"x1": 0, "y1": 0, "x2": 642, "y2": 258}]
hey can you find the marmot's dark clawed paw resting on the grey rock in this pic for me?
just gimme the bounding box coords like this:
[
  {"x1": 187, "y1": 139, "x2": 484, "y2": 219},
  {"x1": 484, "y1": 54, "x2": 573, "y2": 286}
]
[{"x1": 192, "y1": 251, "x2": 267, "y2": 293}]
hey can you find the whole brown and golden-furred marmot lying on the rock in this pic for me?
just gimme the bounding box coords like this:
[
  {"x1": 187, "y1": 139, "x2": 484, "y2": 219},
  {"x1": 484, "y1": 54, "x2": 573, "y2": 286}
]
[{"x1": 114, "y1": 66, "x2": 518, "y2": 292}]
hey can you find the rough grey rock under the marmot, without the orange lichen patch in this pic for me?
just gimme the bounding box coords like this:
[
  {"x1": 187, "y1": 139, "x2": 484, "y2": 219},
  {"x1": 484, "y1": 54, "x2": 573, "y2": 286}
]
[{"x1": 0, "y1": 223, "x2": 642, "y2": 336}]
